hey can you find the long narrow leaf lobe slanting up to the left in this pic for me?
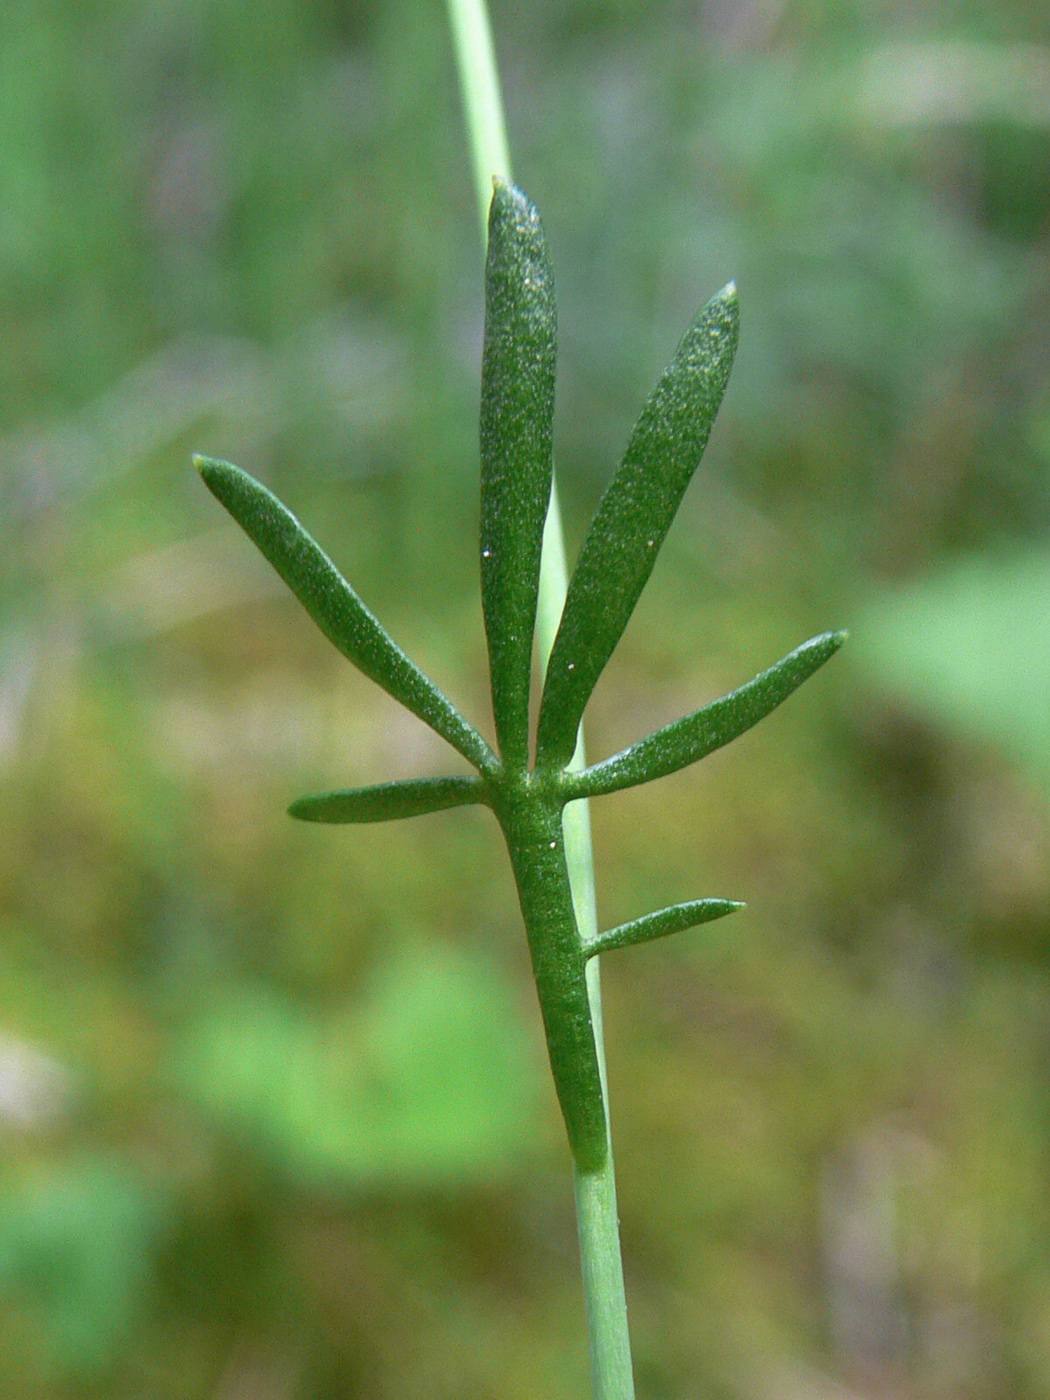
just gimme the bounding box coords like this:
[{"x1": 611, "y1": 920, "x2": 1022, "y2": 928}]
[{"x1": 200, "y1": 456, "x2": 494, "y2": 769}]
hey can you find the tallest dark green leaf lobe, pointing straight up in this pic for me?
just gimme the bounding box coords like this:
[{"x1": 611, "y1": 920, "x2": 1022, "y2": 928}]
[{"x1": 480, "y1": 181, "x2": 557, "y2": 769}]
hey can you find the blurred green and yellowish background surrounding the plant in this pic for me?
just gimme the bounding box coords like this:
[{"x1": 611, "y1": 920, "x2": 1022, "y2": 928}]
[{"x1": 0, "y1": 0, "x2": 1050, "y2": 1400}]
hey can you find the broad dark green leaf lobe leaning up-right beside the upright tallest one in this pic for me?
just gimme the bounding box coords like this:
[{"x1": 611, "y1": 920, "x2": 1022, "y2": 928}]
[{"x1": 536, "y1": 283, "x2": 738, "y2": 767}]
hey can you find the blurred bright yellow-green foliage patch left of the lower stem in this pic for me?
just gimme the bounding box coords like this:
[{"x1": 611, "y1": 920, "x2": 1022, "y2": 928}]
[{"x1": 181, "y1": 946, "x2": 535, "y2": 1190}]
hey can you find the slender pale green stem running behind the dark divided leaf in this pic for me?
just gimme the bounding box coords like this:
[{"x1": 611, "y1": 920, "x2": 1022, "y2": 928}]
[{"x1": 448, "y1": 0, "x2": 634, "y2": 1400}]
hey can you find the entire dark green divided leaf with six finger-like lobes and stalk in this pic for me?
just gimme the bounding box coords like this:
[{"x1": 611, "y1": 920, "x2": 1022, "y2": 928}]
[{"x1": 196, "y1": 182, "x2": 846, "y2": 1169}]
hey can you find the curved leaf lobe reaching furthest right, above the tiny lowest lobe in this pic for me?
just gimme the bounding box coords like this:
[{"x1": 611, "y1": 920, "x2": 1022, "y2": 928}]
[{"x1": 563, "y1": 631, "x2": 848, "y2": 801}]
